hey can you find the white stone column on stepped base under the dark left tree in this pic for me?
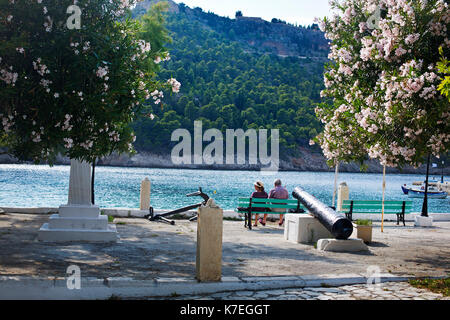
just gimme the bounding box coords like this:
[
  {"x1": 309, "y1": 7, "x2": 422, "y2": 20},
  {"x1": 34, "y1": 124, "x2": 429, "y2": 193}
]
[{"x1": 38, "y1": 160, "x2": 118, "y2": 242}]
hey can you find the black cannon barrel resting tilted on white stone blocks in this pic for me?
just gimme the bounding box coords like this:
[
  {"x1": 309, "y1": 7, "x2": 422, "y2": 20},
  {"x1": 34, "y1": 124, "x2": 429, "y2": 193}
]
[{"x1": 292, "y1": 187, "x2": 353, "y2": 240}]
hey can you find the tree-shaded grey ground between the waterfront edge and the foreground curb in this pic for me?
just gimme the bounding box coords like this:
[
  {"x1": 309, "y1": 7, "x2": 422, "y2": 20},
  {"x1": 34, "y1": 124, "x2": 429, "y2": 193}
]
[{"x1": 0, "y1": 213, "x2": 450, "y2": 279}]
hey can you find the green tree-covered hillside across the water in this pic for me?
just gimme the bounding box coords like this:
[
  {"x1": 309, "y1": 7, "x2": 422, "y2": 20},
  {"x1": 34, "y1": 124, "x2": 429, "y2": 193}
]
[{"x1": 130, "y1": 3, "x2": 325, "y2": 155}]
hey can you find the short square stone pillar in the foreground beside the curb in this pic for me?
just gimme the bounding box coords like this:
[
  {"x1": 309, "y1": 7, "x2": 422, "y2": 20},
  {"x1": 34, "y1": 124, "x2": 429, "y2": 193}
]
[{"x1": 196, "y1": 199, "x2": 223, "y2": 282}]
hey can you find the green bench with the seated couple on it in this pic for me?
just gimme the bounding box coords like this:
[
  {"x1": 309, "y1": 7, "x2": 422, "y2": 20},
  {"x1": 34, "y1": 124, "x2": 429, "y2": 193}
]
[{"x1": 234, "y1": 198, "x2": 306, "y2": 230}]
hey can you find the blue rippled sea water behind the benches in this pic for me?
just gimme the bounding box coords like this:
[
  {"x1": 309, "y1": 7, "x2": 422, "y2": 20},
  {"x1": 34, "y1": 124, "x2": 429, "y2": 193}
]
[{"x1": 0, "y1": 164, "x2": 450, "y2": 213}]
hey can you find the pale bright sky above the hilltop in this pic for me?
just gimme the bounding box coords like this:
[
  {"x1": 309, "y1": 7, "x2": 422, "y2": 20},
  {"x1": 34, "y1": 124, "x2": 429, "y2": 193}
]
[{"x1": 175, "y1": 0, "x2": 330, "y2": 26}]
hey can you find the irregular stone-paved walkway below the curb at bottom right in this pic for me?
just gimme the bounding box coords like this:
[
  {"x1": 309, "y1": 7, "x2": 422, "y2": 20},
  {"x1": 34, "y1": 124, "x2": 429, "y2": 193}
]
[{"x1": 158, "y1": 282, "x2": 450, "y2": 300}]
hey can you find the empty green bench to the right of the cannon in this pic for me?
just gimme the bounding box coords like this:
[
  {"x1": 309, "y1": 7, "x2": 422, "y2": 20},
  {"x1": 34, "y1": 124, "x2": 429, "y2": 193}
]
[{"x1": 341, "y1": 200, "x2": 412, "y2": 226}]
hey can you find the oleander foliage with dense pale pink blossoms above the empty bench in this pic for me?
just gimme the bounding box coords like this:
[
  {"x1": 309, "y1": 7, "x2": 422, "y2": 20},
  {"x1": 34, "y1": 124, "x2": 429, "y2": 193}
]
[{"x1": 315, "y1": 0, "x2": 450, "y2": 167}]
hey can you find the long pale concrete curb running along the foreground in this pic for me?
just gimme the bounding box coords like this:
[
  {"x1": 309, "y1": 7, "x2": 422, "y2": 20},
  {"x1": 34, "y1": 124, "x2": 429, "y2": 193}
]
[{"x1": 0, "y1": 274, "x2": 422, "y2": 300}]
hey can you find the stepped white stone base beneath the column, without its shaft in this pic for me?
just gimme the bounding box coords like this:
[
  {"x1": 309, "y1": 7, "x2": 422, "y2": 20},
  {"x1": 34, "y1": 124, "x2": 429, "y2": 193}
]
[{"x1": 38, "y1": 205, "x2": 118, "y2": 242}]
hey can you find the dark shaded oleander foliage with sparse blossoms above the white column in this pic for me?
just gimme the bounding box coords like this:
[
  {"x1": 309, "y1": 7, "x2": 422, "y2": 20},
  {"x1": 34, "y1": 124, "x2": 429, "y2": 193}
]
[{"x1": 0, "y1": 0, "x2": 179, "y2": 163}]
